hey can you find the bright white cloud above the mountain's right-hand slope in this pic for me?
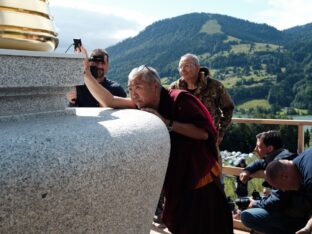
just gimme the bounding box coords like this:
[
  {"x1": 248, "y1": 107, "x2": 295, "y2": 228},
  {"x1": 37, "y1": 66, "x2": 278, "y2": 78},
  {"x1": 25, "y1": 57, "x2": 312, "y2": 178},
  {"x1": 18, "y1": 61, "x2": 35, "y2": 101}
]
[{"x1": 256, "y1": 0, "x2": 312, "y2": 30}]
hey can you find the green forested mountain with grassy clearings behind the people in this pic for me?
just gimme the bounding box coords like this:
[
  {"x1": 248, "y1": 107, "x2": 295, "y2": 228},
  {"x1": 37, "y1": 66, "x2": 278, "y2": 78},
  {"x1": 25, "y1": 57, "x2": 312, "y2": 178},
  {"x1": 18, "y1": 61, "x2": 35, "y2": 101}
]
[{"x1": 107, "y1": 13, "x2": 312, "y2": 111}]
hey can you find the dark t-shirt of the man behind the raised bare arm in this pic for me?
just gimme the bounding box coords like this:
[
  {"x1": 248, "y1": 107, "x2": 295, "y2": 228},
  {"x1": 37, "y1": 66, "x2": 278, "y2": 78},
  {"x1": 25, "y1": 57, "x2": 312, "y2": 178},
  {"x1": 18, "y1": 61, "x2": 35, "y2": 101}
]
[{"x1": 69, "y1": 78, "x2": 127, "y2": 107}]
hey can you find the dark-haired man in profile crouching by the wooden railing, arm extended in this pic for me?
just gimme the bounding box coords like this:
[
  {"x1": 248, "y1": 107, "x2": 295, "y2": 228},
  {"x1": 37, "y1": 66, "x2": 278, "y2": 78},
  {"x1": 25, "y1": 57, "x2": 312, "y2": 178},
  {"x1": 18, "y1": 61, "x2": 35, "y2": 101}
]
[{"x1": 239, "y1": 130, "x2": 297, "y2": 183}]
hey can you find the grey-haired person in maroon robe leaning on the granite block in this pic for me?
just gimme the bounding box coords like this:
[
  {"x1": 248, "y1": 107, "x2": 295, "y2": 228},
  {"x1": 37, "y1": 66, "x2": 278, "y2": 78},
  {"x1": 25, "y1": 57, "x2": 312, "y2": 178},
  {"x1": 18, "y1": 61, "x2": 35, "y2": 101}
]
[{"x1": 84, "y1": 48, "x2": 233, "y2": 234}]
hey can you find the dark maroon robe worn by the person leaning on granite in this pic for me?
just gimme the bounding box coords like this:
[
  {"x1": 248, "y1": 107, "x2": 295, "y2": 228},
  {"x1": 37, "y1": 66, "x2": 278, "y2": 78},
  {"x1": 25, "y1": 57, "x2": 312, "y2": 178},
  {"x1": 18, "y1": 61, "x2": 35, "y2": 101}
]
[{"x1": 158, "y1": 89, "x2": 233, "y2": 234}]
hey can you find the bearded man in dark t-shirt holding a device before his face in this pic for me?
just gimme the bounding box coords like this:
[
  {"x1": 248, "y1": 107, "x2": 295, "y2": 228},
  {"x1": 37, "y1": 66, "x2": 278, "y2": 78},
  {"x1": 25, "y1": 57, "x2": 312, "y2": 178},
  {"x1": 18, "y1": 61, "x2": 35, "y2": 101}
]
[{"x1": 66, "y1": 48, "x2": 127, "y2": 107}]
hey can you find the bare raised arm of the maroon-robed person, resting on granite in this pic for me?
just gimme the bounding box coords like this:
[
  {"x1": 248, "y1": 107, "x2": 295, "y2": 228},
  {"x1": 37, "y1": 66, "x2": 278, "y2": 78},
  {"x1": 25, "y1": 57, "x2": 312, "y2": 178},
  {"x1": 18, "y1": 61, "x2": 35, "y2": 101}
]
[{"x1": 82, "y1": 47, "x2": 136, "y2": 108}]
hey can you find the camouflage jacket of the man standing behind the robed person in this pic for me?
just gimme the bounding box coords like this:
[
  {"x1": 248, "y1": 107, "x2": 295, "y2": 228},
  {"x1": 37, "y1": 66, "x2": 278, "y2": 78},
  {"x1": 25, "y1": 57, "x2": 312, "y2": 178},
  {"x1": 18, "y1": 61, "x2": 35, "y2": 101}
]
[{"x1": 170, "y1": 68, "x2": 234, "y2": 137}]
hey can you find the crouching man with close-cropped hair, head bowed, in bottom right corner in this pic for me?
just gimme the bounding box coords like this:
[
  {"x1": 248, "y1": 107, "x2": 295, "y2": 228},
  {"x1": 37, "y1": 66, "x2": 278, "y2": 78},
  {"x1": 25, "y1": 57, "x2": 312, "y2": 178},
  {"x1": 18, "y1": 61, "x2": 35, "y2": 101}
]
[{"x1": 241, "y1": 148, "x2": 312, "y2": 234}]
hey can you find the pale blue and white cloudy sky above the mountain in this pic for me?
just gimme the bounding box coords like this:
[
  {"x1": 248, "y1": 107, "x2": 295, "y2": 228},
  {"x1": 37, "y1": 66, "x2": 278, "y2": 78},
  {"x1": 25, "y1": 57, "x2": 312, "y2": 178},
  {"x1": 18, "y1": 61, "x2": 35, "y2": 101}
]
[{"x1": 49, "y1": 0, "x2": 312, "y2": 53}]
